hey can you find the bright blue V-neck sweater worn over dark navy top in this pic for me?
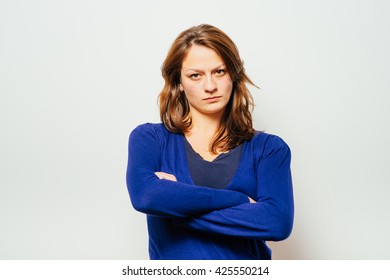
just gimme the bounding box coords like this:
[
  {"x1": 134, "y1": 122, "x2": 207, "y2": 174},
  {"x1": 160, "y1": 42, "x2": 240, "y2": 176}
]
[{"x1": 126, "y1": 123, "x2": 294, "y2": 260}]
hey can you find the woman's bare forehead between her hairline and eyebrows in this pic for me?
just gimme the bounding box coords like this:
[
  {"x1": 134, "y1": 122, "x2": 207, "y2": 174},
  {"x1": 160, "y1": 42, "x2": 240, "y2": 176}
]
[{"x1": 182, "y1": 45, "x2": 224, "y2": 70}]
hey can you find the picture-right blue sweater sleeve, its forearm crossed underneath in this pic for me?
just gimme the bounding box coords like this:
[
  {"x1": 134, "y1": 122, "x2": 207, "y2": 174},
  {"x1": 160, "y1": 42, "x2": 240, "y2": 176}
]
[{"x1": 174, "y1": 136, "x2": 294, "y2": 241}]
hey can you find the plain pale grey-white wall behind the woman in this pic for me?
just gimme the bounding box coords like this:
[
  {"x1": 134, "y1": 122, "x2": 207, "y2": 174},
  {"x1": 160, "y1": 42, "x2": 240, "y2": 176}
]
[{"x1": 0, "y1": 0, "x2": 390, "y2": 259}]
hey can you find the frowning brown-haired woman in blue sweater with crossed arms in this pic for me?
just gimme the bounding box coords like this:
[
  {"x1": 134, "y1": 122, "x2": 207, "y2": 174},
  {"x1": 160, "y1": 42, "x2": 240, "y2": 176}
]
[{"x1": 127, "y1": 25, "x2": 293, "y2": 259}]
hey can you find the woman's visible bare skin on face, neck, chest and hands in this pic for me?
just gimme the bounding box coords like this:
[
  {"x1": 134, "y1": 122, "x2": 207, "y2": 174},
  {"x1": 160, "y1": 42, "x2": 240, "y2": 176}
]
[{"x1": 155, "y1": 45, "x2": 256, "y2": 203}]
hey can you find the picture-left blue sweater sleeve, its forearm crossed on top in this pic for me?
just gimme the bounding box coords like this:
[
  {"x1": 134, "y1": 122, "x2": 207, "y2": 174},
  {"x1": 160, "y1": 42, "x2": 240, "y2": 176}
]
[{"x1": 126, "y1": 124, "x2": 248, "y2": 217}]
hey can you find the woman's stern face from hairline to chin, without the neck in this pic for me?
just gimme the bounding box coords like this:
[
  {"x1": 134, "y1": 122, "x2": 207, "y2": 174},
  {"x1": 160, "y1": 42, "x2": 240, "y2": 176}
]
[{"x1": 179, "y1": 45, "x2": 233, "y2": 117}]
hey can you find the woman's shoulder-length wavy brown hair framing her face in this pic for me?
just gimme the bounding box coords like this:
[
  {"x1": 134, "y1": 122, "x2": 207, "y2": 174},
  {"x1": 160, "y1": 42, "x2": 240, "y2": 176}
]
[{"x1": 159, "y1": 24, "x2": 256, "y2": 154}]
